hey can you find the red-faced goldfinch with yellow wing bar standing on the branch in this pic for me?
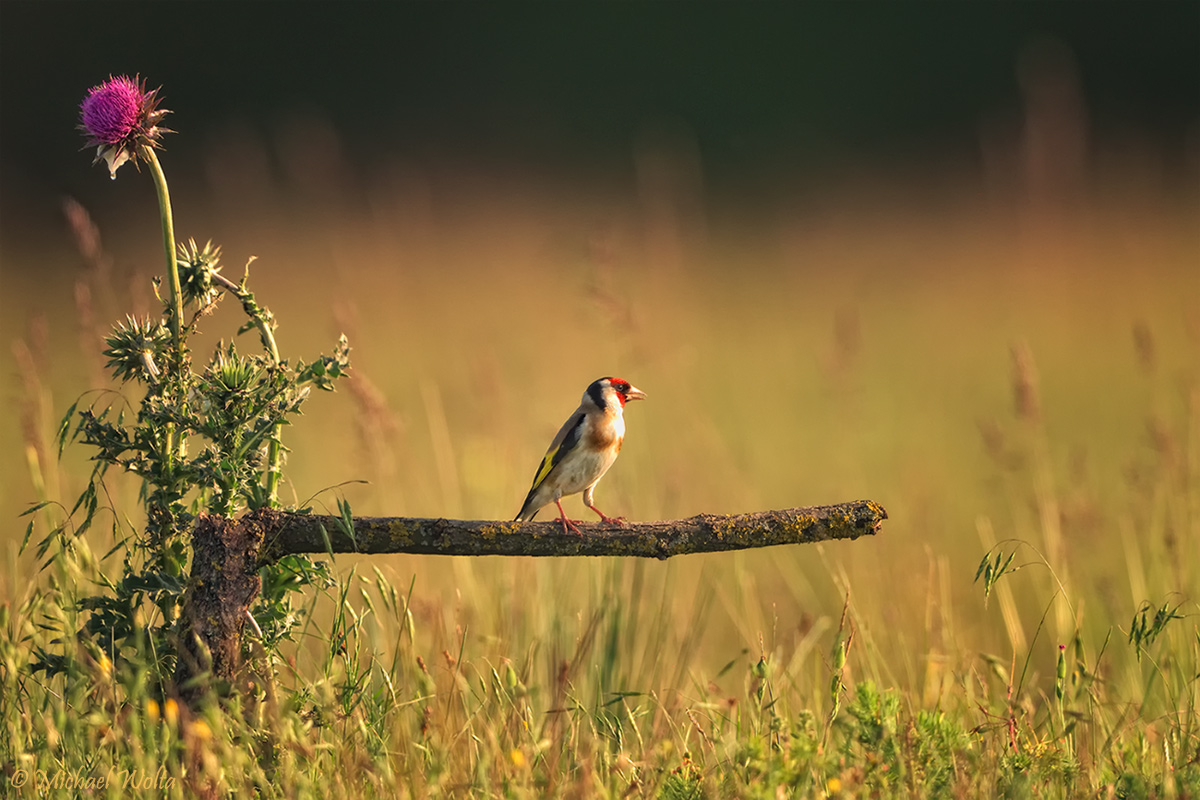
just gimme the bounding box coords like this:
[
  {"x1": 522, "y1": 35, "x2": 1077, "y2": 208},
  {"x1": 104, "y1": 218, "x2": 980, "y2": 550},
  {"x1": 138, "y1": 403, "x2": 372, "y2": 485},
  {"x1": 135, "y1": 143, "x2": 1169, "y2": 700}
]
[{"x1": 516, "y1": 378, "x2": 646, "y2": 534}]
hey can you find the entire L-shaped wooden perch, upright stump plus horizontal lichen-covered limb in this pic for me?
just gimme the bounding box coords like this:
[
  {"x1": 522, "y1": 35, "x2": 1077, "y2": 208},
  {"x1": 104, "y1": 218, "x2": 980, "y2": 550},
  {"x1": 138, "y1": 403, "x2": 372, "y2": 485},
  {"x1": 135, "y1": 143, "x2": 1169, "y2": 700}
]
[{"x1": 175, "y1": 500, "x2": 888, "y2": 706}]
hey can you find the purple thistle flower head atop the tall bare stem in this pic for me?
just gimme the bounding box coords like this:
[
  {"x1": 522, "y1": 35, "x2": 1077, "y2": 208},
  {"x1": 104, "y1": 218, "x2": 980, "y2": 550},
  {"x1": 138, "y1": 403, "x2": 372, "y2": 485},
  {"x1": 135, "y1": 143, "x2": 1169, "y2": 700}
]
[{"x1": 79, "y1": 76, "x2": 170, "y2": 179}]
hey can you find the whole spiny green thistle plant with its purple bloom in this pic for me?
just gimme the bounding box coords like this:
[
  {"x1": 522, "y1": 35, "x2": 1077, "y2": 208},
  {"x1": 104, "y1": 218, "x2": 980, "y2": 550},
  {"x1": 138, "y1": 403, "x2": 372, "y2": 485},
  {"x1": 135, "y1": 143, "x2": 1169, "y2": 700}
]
[{"x1": 26, "y1": 76, "x2": 349, "y2": 678}]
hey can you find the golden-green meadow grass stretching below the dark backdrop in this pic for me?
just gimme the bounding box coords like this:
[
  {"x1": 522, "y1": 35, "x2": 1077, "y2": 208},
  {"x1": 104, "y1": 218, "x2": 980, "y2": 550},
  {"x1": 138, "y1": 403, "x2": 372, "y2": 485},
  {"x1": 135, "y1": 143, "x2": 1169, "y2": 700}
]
[{"x1": 0, "y1": 148, "x2": 1200, "y2": 798}]
